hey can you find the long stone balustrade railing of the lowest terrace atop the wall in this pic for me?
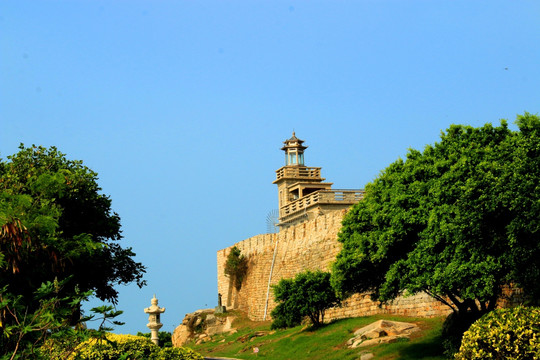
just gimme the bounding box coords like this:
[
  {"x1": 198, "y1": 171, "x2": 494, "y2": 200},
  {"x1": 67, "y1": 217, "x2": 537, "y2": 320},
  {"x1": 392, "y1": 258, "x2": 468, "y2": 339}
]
[{"x1": 280, "y1": 190, "x2": 364, "y2": 218}]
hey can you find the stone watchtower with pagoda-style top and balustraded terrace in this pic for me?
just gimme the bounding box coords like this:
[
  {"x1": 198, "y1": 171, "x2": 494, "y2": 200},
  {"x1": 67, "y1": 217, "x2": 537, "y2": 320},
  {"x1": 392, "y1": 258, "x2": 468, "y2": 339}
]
[{"x1": 273, "y1": 132, "x2": 364, "y2": 230}]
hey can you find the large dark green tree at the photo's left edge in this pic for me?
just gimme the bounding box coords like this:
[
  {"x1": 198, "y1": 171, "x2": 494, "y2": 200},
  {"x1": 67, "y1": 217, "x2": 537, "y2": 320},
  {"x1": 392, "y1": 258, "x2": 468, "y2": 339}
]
[{"x1": 0, "y1": 145, "x2": 145, "y2": 358}]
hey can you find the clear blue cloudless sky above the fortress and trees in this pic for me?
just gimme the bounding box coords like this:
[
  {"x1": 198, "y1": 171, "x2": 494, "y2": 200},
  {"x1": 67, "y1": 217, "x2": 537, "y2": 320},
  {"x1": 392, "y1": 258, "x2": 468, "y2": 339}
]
[{"x1": 0, "y1": 0, "x2": 540, "y2": 333}]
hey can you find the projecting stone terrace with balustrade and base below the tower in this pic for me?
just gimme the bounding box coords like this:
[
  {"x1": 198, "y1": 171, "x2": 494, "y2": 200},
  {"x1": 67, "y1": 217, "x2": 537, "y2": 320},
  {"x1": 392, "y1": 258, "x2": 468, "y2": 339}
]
[{"x1": 279, "y1": 190, "x2": 364, "y2": 228}]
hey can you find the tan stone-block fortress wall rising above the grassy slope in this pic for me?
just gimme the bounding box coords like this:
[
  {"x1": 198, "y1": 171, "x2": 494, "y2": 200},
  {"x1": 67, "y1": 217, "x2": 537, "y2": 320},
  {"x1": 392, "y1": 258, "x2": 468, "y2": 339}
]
[{"x1": 217, "y1": 210, "x2": 450, "y2": 321}]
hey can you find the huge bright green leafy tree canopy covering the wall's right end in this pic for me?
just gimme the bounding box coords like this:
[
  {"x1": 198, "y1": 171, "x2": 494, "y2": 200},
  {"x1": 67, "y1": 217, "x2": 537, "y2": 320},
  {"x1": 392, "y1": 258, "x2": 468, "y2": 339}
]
[{"x1": 332, "y1": 113, "x2": 540, "y2": 313}]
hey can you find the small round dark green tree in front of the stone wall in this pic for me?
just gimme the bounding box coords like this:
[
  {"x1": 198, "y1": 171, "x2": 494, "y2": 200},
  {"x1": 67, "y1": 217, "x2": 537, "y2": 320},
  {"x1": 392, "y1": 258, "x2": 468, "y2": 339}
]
[{"x1": 271, "y1": 270, "x2": 339, "y2": 329}]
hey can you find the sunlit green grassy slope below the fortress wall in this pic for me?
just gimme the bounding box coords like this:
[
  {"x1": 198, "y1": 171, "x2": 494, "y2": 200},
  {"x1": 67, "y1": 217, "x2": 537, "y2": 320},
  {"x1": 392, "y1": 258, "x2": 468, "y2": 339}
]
[{"x1": 187, "y1": 315, "x2": 445, "y2": 360}]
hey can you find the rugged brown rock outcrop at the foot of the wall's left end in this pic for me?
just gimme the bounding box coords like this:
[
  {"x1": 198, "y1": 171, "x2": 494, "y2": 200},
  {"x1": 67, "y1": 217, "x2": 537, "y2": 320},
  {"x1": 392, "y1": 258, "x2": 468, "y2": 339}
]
[{"x1": 172, "y1": 309, "x2": 236, "y2": 347}]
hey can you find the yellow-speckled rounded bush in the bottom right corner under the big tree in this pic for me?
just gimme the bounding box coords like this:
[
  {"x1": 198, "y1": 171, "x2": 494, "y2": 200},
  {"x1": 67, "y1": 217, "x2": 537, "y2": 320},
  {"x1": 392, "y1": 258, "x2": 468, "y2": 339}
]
[{"x1": 455, "y1": 306, "x2": 540, "y2": 360}]
